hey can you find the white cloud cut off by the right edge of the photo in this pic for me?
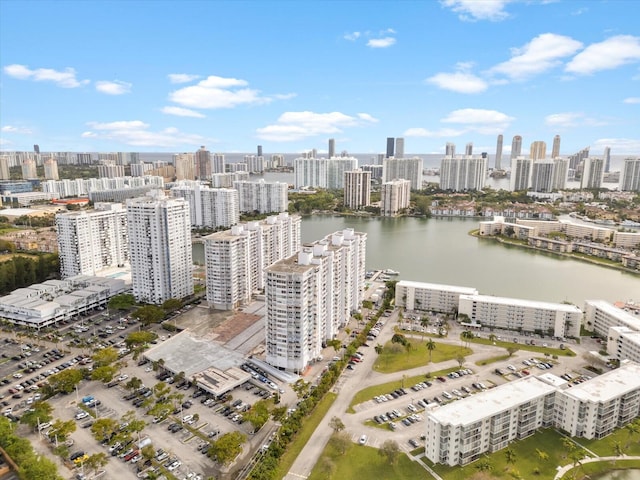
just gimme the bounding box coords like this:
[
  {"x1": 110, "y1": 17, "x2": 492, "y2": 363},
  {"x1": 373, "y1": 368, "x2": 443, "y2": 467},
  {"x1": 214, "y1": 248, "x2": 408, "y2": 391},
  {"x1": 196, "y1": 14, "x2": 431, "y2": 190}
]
[{"x1": 565, "y1": 35, "x2": 640, "y2": 75}]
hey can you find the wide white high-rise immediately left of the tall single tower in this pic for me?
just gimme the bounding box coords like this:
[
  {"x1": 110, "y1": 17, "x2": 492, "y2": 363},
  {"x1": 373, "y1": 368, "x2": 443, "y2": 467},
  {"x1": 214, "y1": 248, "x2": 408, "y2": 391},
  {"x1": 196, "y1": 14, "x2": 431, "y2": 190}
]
[{"x1": 56, "y1": 203, "x2": 129, "y2": 279}]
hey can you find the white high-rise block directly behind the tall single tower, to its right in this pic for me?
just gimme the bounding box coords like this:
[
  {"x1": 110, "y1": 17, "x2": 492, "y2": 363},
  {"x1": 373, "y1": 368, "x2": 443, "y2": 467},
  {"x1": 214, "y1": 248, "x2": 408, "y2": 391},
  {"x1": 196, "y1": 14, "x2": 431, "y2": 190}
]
[{"x1": 171, "y1": 180, "x2": 240, "y2": 228}]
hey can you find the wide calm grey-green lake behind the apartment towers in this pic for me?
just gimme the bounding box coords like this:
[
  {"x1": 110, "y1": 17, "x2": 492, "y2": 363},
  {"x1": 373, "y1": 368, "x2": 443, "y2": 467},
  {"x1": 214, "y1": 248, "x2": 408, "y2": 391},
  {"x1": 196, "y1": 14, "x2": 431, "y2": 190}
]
[{"x1": 194, "y1": 215, "x2": 640, "y2": 308}]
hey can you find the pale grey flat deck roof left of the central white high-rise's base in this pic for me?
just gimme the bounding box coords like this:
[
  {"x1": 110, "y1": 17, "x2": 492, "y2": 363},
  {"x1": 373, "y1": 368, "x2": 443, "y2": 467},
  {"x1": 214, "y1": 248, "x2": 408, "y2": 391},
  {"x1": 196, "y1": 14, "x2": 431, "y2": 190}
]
[{"x1": 144, "y1": 330, "x2": 245, "y2": 378}]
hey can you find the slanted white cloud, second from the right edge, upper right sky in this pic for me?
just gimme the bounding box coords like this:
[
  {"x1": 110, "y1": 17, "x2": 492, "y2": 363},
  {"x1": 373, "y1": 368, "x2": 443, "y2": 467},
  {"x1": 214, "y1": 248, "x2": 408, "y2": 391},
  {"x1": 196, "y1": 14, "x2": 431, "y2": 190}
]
[{"x1": 490, "y1": 33, "x2": 582, "y2": 80}]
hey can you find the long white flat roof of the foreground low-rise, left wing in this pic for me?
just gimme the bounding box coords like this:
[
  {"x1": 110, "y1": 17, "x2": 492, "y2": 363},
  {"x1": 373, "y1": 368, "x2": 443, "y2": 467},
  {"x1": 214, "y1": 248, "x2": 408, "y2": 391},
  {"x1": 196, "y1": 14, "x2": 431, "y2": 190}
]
[{"x1": 429, "y1": 377, "x2": 556, "y2": 425}]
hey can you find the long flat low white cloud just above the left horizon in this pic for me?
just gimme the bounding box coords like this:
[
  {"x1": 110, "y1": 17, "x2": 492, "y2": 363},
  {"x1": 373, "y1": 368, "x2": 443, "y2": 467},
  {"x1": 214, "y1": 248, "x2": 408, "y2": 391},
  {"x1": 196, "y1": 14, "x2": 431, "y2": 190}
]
[{"x1": 81, "y1": 120, "x2": 204, "y2": 147}]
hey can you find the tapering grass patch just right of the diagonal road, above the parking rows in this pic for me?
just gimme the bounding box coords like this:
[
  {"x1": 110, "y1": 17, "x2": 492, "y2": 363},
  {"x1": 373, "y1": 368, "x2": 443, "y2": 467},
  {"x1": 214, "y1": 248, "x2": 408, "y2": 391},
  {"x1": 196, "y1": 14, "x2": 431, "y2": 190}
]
[{"x1": 373, "y1": 341, "x2": 473, "y2": 373}]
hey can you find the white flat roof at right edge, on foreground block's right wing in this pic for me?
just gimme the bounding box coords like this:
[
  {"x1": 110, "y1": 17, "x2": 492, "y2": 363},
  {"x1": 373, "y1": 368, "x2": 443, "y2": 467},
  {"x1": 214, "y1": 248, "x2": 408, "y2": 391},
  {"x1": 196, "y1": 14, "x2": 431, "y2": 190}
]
[{"x1": 564, "y1": 361, "x2": 640, "y2": 402}]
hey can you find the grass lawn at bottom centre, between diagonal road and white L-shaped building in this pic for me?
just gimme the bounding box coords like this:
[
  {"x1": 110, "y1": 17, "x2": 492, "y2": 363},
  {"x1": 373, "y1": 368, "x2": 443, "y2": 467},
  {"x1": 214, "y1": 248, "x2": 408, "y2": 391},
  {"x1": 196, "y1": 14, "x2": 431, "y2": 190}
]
[{"x1": 308, "y1": 436, "x2": 430, "y2": 480}]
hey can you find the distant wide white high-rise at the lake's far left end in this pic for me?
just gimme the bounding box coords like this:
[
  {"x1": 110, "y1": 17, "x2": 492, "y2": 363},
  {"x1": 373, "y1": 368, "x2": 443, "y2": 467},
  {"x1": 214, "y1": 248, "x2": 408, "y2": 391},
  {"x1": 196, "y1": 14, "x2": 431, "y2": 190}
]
[{"x1": 233, "y1": 178, "x2": 289, "y2": 213}]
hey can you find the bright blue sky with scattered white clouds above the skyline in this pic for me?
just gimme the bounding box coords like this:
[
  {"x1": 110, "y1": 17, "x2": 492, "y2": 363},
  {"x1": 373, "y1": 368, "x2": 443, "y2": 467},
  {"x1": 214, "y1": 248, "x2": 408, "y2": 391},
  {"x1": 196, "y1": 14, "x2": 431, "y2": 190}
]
[{"x1": 0, "y1": 0, "x2": 640, "y2": 155}]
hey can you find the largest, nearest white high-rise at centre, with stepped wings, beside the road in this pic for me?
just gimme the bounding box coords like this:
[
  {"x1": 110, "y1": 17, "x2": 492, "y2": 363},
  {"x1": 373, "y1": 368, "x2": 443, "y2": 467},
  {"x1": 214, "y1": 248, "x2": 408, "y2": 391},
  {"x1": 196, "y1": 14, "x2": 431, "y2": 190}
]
[{"x1": 265, "y1": 229, "x2": 366, "y2": 373}]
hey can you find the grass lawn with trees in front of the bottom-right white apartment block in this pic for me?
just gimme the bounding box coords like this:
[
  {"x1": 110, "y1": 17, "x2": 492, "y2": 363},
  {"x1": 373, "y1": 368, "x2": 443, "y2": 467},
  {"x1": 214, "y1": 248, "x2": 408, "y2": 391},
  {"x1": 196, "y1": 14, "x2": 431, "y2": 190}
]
[{"x1": 430, "y1": 429, "x2": 570, "y2": 480}]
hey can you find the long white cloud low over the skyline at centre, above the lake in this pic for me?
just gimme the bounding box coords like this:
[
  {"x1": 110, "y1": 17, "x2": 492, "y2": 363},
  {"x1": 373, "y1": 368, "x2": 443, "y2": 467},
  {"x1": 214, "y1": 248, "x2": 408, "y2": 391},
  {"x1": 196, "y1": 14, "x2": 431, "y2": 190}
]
[{"x1": 257, "y1": 111, "x2": 378, "y2": 142}]
